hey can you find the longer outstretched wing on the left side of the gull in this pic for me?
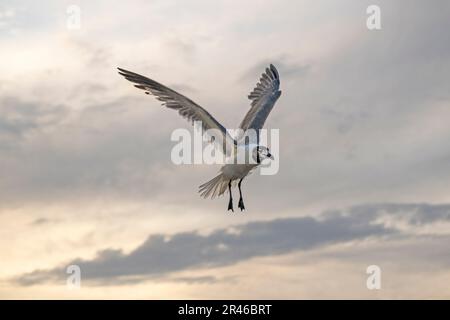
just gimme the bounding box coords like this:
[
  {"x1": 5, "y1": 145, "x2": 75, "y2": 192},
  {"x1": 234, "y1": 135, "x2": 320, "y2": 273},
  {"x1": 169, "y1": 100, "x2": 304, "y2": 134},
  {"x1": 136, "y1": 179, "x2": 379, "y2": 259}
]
[{"x1": 117, "y1": 68, "x2": 236, "y2": 155}]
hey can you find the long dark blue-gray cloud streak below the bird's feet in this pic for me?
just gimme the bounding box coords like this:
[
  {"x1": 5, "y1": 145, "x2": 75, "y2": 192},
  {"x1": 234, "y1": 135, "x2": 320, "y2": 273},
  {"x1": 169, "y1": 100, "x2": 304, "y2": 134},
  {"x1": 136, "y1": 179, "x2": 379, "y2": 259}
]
[{"x1": 16, "y1": 204, "x2": 450, "y2": 285}]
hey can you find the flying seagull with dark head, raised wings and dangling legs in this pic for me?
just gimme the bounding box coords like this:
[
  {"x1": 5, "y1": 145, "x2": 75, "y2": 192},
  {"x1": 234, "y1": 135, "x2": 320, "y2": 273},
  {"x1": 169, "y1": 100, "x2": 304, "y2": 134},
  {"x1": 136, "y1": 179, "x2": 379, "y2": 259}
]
[{"x1": 117, "y1": 64, "x2": 281, "y2": 212}]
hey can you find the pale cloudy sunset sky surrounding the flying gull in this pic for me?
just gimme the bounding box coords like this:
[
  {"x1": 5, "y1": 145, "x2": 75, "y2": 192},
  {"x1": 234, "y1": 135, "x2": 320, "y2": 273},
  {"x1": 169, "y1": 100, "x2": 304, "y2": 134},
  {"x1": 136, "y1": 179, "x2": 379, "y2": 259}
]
[{"x1": 0, "y1": 0, "x2": 450, "y2": 299}]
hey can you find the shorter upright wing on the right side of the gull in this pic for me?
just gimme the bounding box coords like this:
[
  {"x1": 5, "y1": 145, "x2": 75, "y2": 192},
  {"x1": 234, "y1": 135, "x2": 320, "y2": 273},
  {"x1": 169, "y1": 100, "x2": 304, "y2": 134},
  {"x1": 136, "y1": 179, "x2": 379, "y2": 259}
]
[{"x1": 239, "y1": 64, "x2": 281, "y2": 131}]
